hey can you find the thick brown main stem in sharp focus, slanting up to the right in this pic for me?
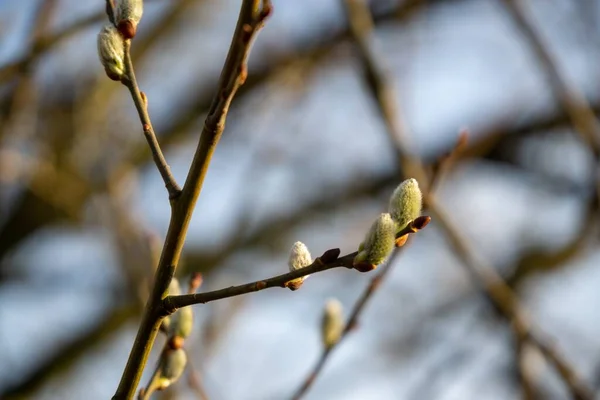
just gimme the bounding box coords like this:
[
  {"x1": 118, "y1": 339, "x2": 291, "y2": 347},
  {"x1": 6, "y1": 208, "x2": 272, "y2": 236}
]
[{"x1": 113, "y1": 0, "x2": 272, "y2": 400}]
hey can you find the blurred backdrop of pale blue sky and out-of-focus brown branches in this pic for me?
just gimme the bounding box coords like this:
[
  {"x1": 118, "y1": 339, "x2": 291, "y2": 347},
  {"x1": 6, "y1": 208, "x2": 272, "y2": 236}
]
[{"x1": 0, "y1": 0, "x2": 600, "y2": 400}]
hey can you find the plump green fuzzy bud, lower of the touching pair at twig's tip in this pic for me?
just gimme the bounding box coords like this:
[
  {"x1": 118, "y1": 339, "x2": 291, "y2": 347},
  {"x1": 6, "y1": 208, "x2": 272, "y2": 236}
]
[{"x1": 353, "y1": 213, "x2": 396, "y2": 272}]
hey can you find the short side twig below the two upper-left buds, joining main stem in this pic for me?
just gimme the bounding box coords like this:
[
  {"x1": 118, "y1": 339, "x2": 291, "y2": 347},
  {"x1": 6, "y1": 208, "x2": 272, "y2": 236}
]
[{"x1": 123, "y1": 40, "x2": 181, "y2": 201}]
